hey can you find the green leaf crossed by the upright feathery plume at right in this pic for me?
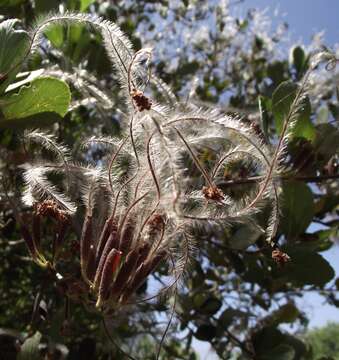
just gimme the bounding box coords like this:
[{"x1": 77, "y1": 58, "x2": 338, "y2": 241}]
[{"x1": 272, "y1": 81, "x2": 315, "y2": 140}]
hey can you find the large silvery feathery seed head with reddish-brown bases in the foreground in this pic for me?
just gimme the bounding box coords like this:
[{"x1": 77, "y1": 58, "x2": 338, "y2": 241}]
[{"x1": 16, "y1": 13, "x2": 324, "y2": 311}]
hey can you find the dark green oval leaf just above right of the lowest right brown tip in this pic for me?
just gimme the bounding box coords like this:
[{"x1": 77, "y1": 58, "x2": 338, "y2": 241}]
[{"x1": 280, "y1": 181, "x2": 314, "y2": 238}]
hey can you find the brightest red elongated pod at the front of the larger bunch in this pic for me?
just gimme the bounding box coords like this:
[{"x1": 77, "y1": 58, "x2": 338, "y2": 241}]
[{"x1": 96, "y1": 249, "x2": 122, "y2": 307}]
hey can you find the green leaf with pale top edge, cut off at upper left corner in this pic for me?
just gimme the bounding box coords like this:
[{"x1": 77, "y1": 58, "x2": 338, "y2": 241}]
[{"x1": 0, "y1": 19, "x2": 30, "y2": 94}]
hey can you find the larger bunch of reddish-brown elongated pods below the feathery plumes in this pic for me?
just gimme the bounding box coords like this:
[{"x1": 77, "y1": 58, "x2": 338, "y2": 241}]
[{"x1": 80, "y1": 212, "x2": 167, "y2": 309}]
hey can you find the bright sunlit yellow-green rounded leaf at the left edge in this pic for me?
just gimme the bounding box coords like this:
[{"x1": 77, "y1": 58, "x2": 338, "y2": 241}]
[{"x1": 1, "y1": 77, "x2": 71, "y2": 120}]
